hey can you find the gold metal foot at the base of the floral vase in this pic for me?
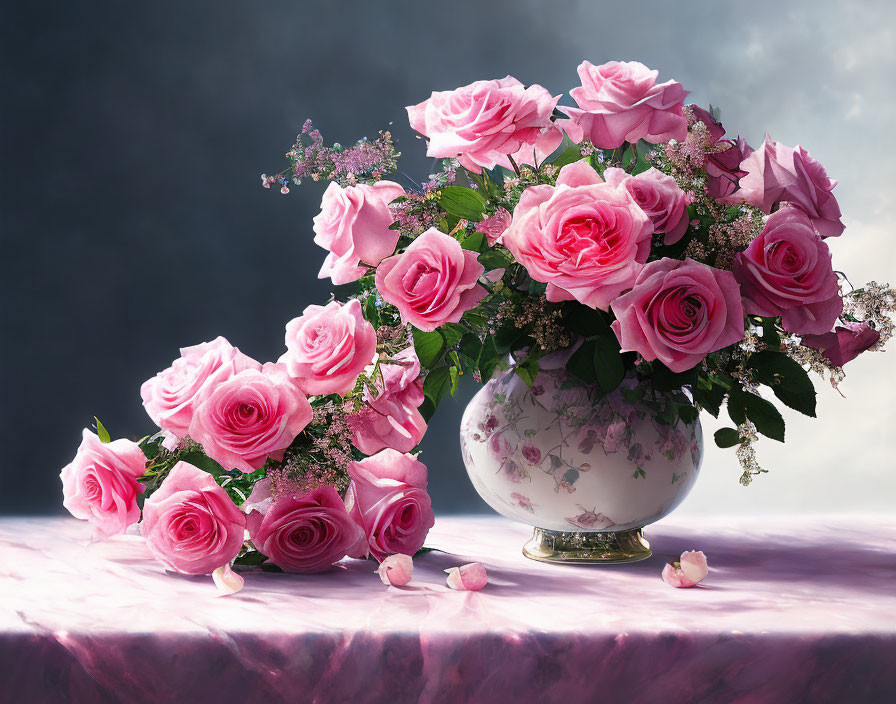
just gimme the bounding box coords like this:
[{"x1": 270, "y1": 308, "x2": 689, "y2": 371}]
[{"x1": 523, "y1": 528, "x2": 653, "y2": 565}]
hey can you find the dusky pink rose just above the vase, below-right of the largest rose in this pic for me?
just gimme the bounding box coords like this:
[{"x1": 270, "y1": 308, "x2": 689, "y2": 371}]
[{"x1": 612, "y1": 259, "x2": 744, "y2": 372}]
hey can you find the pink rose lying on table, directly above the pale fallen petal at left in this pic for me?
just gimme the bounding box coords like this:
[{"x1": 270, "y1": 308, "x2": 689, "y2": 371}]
[{"x1": 140, "y1": 462, "x2": 246, "y2": 574}]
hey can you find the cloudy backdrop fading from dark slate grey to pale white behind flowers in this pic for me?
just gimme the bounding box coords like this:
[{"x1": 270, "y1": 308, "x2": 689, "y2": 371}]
[{"x1": 0, "y1": 0, "x2": 896, "y2": 513}]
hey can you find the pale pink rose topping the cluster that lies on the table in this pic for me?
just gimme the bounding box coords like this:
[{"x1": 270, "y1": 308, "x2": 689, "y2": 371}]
[{"x1": 280, "y1": 299, "x2": 376, "y2": 396}]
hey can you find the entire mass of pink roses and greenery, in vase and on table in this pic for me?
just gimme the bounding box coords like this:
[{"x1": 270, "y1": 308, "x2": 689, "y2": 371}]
[{"x1": 62, "y1": 62, "x2": 894, "y2": 583}]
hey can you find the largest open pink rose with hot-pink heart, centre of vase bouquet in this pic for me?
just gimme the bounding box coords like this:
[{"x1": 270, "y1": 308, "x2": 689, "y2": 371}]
[{"x1": 503, "y1": 162, "x2": 653, "y2": 310}]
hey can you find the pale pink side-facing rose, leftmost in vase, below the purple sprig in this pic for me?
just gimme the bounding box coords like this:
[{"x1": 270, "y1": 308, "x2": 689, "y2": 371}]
[{"x1": 314, "y1": 181, "x2": 404, "y2": 284}]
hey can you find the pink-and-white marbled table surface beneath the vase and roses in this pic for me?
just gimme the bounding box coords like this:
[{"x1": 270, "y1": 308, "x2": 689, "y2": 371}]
[{"x1": 0, "y1": 516, "x2": 896, "y2": 704}]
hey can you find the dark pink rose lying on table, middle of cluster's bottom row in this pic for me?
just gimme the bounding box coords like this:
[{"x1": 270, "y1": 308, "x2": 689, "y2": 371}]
[{"x1": 243, "y1": 479, "x2": 367, "y2": 572}]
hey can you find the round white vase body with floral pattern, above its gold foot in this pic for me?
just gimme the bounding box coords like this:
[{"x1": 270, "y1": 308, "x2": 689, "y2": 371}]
[{"x1": 460, "y1": 368, "x2": 703, "y2": 532}]
